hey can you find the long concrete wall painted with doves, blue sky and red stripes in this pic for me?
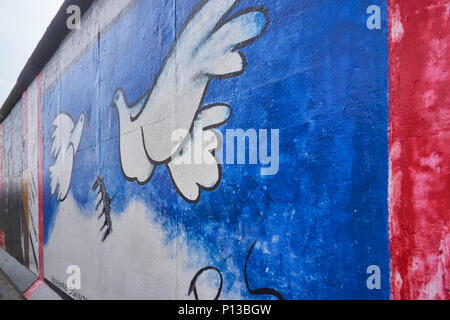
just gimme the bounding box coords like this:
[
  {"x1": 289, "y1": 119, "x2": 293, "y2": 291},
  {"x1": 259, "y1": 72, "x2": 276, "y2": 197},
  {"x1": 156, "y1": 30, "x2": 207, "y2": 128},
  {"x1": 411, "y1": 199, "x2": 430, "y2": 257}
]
[{"x1": 0, "y1": 0, "x2": 449, "y2": 299}]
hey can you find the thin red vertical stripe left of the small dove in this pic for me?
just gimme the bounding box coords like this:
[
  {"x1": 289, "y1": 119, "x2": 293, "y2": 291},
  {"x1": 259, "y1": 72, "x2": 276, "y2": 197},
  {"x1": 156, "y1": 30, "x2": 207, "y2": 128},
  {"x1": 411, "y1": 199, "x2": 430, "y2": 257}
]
[{"x1": 37, "y1": 72, "x2": 44, "y2": 280}]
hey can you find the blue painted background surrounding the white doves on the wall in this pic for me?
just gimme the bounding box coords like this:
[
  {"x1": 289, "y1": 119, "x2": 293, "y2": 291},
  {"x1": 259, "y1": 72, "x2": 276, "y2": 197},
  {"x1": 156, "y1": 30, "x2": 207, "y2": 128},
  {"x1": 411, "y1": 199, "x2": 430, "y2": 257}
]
[{"x1": 43, "y1": 0, "x2": 390, "y2": 299}]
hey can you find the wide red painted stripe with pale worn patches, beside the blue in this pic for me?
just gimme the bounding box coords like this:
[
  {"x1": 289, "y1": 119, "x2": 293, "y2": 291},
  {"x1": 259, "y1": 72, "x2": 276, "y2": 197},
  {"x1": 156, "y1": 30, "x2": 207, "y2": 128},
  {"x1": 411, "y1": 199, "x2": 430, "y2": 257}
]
[{"x1": 389, "y1": 0, "x2": 450, "y2": 299}]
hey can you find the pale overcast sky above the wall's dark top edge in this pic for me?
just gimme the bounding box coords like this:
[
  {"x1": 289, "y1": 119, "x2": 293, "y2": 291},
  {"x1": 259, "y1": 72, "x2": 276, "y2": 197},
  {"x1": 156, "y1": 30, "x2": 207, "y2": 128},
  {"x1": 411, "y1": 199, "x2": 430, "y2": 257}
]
[{"x1": 0, "y1": 0, "x2": 64, "y2": 107}]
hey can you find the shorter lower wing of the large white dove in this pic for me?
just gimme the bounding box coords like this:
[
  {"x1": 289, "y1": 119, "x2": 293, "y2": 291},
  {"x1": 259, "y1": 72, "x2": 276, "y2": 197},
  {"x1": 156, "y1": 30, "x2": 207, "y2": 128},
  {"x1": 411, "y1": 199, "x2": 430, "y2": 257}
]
[{"x1": 167, "y1": 104, "x2": 231, "y2": 202}]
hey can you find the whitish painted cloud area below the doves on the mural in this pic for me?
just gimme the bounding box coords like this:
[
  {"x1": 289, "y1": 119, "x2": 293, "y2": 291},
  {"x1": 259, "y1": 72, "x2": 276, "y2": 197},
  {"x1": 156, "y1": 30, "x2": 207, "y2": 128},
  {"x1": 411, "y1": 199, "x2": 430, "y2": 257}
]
[{"x1": 44, "y1": 193, "x2": 242, "y2": 300}]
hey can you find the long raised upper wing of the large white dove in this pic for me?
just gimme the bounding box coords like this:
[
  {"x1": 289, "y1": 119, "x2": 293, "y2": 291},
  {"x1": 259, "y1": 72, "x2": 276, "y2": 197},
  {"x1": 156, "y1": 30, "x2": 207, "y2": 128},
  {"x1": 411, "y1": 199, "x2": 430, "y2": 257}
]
[{"x1": 140, "y1": 0, "x2": 268, "y2": 163}]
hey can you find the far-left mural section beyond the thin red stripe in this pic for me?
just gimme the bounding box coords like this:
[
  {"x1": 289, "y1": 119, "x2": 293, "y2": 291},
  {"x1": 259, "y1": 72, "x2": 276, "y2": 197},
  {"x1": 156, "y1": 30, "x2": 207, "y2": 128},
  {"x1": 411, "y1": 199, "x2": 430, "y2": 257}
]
[{"x1": 0, "y1": 90, "x2": 39, "y2": 274}]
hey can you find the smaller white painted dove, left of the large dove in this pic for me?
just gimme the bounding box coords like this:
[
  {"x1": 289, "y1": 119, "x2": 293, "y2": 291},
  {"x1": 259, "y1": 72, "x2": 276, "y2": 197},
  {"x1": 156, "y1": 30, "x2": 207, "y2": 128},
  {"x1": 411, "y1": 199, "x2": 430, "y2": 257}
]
[{"x1": 49, "y1": 113, "x2": 85, "y2": 201}]
